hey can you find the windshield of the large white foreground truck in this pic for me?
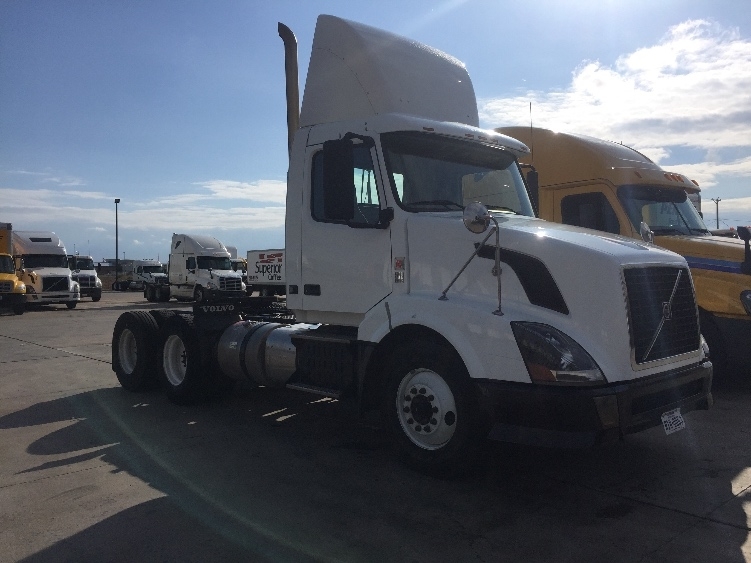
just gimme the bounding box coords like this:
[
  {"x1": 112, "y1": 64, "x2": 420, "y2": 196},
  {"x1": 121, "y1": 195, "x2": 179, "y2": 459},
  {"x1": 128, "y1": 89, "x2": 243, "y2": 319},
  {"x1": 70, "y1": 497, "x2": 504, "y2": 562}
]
[{"x1": 382, "y1": 132, "x2": 534, "y2": 216}]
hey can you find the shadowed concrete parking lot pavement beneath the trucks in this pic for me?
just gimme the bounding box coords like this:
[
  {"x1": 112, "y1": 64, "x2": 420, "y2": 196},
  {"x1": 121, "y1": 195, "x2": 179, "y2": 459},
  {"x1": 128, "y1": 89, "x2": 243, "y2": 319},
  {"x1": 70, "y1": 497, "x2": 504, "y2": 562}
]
[{"x1": 0, "y1": 292, "x2": 751, "y2": 562}]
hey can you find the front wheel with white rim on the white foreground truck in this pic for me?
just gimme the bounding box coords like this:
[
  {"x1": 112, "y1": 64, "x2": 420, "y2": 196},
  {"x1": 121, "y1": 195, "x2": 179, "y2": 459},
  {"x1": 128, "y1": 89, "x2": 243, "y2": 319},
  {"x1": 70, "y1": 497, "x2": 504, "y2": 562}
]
[{"x1": 383, "y1": 342, "x2": 487, "y2": 477}]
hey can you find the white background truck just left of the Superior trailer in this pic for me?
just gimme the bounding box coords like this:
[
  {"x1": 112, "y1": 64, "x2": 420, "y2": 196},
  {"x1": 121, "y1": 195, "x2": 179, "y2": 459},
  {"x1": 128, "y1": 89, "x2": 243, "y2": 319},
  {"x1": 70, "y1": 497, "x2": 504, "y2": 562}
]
[{"x1": 167, "y1": 234, "x2": 245, "y2": 303}]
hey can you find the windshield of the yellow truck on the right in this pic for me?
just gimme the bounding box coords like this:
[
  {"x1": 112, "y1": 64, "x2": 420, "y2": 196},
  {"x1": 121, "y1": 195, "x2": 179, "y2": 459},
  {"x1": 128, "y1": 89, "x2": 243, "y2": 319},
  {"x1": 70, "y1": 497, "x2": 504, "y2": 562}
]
[{"x1": 618, "y1": 186, "x2": 709, "y2": 236}]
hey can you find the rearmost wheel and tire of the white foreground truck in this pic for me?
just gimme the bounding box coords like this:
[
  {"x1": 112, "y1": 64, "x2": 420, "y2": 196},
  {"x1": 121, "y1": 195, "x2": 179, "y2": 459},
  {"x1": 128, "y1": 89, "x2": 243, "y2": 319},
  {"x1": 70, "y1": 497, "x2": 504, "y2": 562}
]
[{"x1": 112, "y1": 311, "x2": 159, "y2": 392}]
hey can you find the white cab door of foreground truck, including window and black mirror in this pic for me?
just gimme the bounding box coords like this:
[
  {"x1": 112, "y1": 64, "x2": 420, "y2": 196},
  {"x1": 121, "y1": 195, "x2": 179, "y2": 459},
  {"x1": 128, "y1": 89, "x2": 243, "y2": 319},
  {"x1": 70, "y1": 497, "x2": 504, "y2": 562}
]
[{"x1": 298, "y1": 135, "x2": 393, "y2": 325}]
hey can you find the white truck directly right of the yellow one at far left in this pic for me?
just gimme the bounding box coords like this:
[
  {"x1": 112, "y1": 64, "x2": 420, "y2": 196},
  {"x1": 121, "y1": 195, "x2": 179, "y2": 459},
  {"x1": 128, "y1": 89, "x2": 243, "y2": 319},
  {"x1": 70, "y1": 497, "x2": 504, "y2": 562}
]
[{"x1": 13, "y1": 231, "x2": 81, "y2": 309}]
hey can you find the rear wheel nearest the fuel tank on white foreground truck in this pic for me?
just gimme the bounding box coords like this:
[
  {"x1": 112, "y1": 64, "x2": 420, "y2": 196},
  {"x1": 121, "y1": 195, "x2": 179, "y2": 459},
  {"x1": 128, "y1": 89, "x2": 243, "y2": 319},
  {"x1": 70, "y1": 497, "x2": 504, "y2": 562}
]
[{"x1": 158, "y1": 315, "x2": 208, "y2": 405}]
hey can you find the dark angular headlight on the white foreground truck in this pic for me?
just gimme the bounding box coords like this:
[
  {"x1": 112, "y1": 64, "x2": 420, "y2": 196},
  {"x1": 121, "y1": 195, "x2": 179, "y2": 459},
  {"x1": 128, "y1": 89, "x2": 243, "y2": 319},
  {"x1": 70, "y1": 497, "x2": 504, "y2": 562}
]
[{"x1": 511, "y1": 322, "x2": 606, "y2": 383}]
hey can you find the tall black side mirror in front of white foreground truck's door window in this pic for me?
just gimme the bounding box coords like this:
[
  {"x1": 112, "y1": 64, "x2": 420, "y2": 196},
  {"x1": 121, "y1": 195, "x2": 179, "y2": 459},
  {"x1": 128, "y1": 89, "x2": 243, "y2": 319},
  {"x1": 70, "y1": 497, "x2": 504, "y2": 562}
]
[{"x1": 323, "y1": 139, "x2": 355, "y2": 222}]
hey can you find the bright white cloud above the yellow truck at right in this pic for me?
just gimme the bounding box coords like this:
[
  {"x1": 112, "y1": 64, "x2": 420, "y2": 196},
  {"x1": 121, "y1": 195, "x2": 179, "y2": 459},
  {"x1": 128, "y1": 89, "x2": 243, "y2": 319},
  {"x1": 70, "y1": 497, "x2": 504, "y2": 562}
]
[{"x1": 480, "y1": 20, "x2": 751, "y2": 192}]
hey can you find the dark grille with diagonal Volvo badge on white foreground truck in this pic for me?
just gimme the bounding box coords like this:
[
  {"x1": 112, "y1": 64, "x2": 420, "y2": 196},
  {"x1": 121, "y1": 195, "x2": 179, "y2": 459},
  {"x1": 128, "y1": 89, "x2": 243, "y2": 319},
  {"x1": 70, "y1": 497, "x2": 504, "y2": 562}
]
[{"x1": 624, "y1": 266, "x2": 699, "y2": 364}]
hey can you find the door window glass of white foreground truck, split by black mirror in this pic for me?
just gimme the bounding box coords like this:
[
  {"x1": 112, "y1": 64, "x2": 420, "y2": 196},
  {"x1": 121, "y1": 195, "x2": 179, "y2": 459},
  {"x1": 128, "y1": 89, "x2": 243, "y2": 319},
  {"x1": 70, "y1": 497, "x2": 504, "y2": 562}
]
[{"x1": 311, "y1": 146, "x2": 381, "y2": 226}]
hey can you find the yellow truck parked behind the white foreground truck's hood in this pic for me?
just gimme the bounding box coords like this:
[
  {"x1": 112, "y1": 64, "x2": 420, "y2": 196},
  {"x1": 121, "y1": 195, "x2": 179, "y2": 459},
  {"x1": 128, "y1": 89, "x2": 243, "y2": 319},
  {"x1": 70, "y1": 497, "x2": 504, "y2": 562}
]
[{"x1": 498, "y1": 127, "x2": 751, "y2": 374}]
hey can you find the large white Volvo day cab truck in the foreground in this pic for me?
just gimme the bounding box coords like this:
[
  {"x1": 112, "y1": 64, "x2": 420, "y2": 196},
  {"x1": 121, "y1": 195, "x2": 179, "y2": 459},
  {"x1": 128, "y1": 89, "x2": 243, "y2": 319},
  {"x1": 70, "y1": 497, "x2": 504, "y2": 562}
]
[{"x1": 112, "y1": 16, "x2": 712, "y2": 475}]
